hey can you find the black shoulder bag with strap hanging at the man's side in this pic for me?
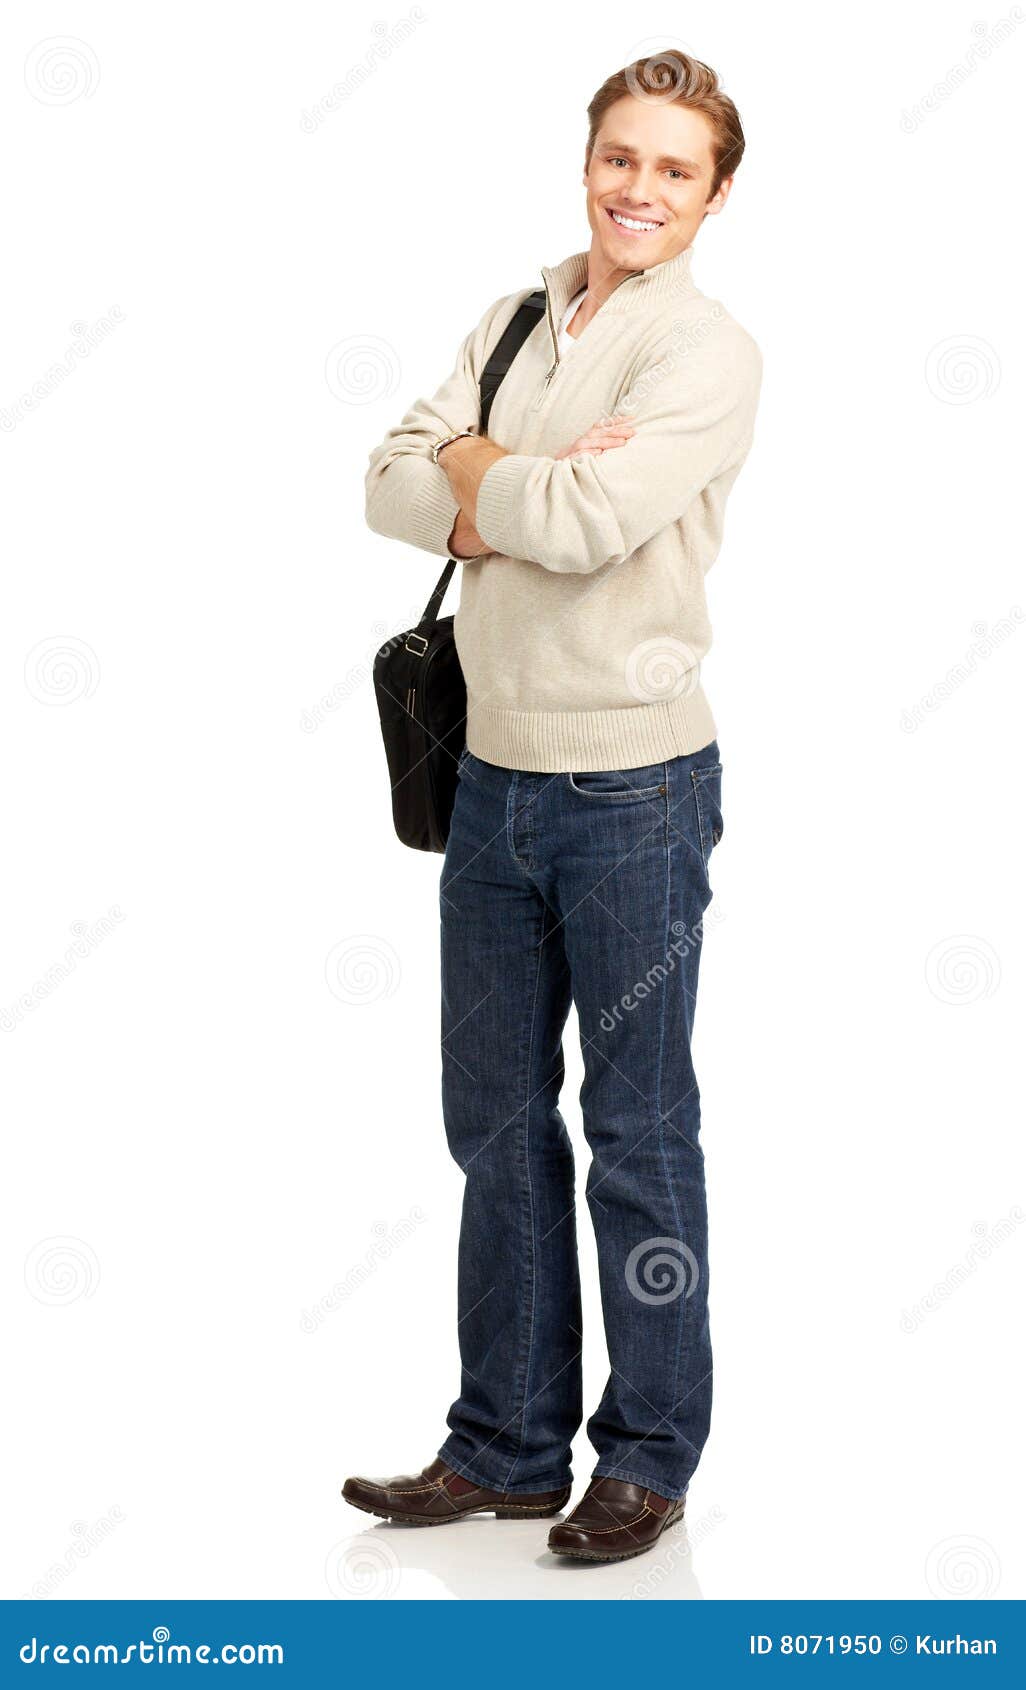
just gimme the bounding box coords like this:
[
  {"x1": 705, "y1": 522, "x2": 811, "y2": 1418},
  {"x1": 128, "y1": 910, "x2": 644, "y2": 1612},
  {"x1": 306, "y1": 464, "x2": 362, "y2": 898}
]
[{"x1": 374, "y1": 289, "x2": 544, "y2": 850}]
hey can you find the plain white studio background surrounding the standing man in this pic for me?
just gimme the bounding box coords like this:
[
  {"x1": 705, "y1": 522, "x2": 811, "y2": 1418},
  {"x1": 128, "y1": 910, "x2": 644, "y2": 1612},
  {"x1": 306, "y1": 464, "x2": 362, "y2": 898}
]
[{"x1": 0, "y1": 0, "x2": 1026, "y2": 1599}]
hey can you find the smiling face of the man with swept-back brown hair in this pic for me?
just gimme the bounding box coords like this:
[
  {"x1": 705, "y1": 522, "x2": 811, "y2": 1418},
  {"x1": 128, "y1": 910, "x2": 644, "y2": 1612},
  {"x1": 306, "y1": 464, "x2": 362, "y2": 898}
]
[{"x1": 585, "y1": 95, "x2": 730, "y2": 274}]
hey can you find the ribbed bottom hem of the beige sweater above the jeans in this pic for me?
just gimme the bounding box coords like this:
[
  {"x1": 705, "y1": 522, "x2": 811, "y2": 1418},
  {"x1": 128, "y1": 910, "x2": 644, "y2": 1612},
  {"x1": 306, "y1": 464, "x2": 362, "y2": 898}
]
[{"x1": 467, "y1": 686, "x2": 717, "y2": 774}]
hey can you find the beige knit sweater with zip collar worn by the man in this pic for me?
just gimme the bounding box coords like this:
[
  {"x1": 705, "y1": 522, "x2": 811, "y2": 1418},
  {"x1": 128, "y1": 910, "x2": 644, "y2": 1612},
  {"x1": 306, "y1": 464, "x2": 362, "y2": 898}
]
[{"x1": 367, "y1": 248, "x2": 762, "y2": 772}]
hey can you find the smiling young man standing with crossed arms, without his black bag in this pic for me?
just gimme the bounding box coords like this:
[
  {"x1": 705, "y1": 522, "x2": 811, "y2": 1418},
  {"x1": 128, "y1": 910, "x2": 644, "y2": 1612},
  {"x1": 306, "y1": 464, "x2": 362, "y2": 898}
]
[{"x1": 343, "y1": 52, "x2": 761, "y2": 1560}]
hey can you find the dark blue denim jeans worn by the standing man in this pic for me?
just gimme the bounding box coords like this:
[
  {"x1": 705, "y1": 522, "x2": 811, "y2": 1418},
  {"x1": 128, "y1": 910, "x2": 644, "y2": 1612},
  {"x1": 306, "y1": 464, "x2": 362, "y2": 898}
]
[{"x1": 439, "y1": 742, "x2": 722, "y2": 1499}]
